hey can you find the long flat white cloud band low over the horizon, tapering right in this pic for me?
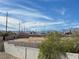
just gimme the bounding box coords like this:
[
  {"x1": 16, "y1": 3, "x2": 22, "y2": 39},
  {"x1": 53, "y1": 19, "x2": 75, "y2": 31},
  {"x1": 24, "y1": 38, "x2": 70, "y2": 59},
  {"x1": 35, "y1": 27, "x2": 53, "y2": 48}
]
[{"x1": 22, "y1": 22, "x2": 64, "y2": 28}]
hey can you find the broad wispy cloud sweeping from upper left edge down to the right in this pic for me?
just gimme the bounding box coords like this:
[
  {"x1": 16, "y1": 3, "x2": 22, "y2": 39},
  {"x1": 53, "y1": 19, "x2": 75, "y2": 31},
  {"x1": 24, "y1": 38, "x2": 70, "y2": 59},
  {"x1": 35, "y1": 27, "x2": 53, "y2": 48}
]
[{"x1": 0, "y1": 0, "x2": 53, "y2": 21}]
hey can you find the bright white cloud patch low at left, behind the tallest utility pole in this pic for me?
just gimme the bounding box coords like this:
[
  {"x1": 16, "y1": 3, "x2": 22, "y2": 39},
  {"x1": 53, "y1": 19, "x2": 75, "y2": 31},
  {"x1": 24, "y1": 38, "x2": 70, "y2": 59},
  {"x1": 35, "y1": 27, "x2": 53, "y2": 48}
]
[{"x1": 0, "y1": 16, "x2": 19, "y2": 28}]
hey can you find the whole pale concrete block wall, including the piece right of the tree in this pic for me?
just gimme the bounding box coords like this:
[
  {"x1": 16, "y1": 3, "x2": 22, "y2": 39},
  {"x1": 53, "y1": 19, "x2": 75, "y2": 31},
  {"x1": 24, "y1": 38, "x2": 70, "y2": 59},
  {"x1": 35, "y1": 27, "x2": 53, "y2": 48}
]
[{"x1": 4, "y1": 42, "x2": 78, "y2": 59}]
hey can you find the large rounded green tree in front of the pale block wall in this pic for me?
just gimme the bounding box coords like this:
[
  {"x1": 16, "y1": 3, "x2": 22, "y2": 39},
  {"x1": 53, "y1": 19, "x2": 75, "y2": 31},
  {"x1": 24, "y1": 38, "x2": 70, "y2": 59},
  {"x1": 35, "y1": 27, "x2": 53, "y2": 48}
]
[{"x1": 39, "y1": 32, "x2": 67, "y2": 59}]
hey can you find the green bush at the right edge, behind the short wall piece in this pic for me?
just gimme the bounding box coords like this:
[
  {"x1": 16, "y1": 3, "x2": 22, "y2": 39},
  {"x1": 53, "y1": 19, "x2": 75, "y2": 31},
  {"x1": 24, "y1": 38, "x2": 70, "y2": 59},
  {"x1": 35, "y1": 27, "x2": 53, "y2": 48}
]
[{"x1": 61, "y1": 37, "x2": 79, "y2": 53}]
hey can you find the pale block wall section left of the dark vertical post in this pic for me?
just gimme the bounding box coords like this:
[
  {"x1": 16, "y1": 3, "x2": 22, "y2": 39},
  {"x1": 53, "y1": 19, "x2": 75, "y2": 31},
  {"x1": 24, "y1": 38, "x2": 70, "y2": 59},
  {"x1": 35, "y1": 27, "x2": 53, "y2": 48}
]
[{"x1": 4, "y1": 42, "x2": 26, "y2": 59}]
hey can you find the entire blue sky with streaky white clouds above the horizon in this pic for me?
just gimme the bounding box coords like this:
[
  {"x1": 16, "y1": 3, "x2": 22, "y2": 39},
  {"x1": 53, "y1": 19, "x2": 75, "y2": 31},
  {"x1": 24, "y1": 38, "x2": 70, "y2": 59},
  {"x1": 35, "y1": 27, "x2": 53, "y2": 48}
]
[{"x1": 0, "y1": 0, "x2": 79, "y2": 31}]
